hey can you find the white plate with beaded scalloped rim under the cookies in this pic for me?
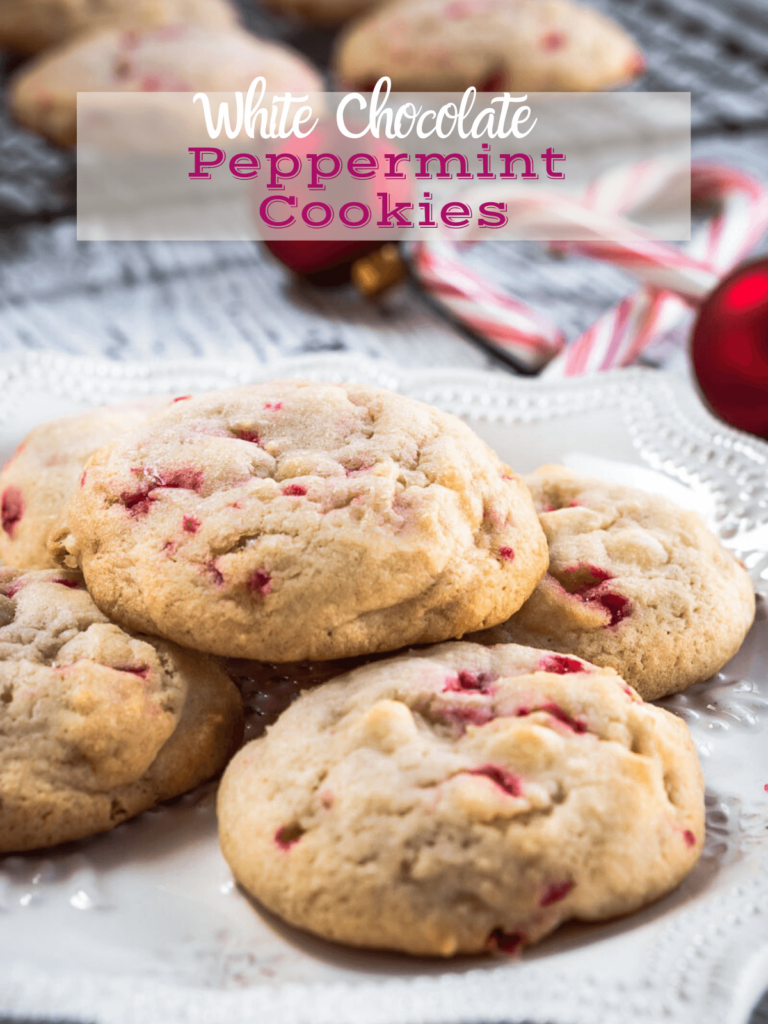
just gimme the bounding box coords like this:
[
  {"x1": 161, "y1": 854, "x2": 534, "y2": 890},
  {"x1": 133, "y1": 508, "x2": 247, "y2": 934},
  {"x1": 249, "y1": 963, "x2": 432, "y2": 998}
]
[{"x1": 0, "y1": 355, "x2": 768, "y2": 1024}]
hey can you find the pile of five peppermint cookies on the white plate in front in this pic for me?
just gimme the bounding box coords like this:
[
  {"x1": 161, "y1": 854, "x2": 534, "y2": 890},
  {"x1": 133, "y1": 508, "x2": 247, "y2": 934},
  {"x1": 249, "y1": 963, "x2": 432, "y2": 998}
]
[{"x1": 0, "y1": 382, "x2": 755, "y2": 956}]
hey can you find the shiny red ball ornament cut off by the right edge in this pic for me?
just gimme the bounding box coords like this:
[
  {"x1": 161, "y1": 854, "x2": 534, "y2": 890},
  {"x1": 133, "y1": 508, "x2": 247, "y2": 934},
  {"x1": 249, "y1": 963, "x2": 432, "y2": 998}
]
[{"x1": 691, "y1": 257, "x2": 768, "y2": 438}]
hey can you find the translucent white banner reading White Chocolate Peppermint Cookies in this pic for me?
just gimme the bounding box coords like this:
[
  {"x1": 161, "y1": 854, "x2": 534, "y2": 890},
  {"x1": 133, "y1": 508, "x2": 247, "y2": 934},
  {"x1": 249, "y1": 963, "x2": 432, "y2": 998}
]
[{"x1": 77, "y1": 89, "x2": 690, "y2": 242}]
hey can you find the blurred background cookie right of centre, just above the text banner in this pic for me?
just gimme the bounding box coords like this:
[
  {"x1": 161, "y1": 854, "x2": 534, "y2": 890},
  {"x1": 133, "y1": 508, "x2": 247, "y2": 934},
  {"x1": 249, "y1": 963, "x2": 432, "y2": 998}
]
[{"x1": 335, "y1": 0, "x2": 643, "y2": 92}]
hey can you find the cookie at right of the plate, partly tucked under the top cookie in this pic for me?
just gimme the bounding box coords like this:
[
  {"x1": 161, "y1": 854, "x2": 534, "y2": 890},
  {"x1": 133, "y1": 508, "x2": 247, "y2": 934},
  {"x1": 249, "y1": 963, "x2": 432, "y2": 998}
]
[{"x1": 476, "y1": 466, "x2": 755, "y2": 700}]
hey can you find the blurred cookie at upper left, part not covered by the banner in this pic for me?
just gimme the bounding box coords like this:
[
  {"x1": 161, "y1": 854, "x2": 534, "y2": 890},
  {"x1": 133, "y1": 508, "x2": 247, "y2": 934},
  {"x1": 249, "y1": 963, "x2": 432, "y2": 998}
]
[{"x1": 10, "y1": 25, "x2": 323, "y2": 145}]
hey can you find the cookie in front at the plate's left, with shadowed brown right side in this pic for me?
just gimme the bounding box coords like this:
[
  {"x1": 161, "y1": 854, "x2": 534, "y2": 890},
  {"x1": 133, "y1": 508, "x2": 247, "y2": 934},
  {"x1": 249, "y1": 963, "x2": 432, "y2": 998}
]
[{"x1": 0, "y1": 569, "x2": 243, "y2": 853}]
